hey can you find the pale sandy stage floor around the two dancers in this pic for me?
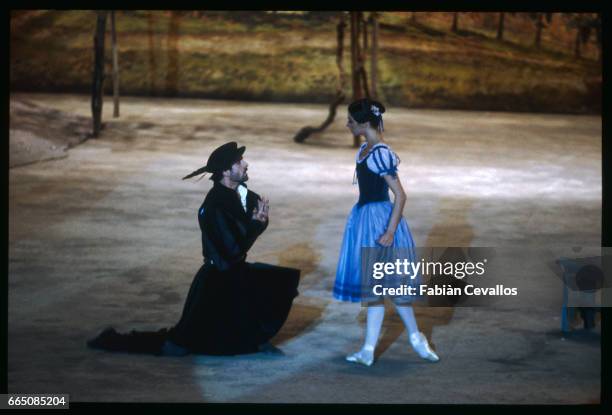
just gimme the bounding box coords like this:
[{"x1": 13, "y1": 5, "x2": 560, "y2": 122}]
[{"x1": 8, "y1": 94, "x2": 601, "y2": 404}]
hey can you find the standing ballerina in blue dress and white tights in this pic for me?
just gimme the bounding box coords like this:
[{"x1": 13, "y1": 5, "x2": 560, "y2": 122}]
[{"x1": 333, "y1": 98, "x2": 439, "y2": 366}]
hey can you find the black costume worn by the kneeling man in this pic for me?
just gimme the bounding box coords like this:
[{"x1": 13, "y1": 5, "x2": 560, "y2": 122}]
[{"x1": 88, "y1": 143, "x2": 300, "y2": 355}]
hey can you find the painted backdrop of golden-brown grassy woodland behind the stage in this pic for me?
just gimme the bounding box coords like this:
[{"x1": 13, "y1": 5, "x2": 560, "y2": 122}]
[{"x1": 10, "y1": 10, "x2": 602, "y2": 113}]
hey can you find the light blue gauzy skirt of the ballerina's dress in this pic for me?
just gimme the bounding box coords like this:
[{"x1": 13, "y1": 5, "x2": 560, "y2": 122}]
[{"x1": 333, "y1": 201, "x2": 419, "y2": 303}]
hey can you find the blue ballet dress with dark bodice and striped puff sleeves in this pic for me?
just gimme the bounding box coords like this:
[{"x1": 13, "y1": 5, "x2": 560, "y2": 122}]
[{"x1": 333, "y1": 143, "x2": 419, "y2": 303}]
